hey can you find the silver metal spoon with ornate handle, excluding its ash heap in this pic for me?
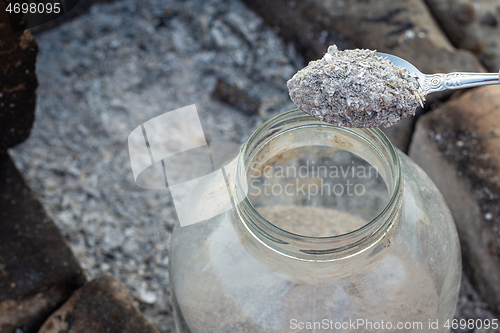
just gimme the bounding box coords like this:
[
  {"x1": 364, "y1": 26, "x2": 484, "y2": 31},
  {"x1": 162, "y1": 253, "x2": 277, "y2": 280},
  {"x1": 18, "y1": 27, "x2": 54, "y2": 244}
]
[{"x1": 377, "y1": 52, "x2": 500, "y2": 95}]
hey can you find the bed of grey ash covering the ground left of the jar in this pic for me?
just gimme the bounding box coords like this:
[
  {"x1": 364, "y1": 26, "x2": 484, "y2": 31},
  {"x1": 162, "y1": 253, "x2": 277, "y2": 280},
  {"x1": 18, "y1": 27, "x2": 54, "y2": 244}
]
[{"x1": 11, "y1": 0, "x2": 498, "y2": 332}]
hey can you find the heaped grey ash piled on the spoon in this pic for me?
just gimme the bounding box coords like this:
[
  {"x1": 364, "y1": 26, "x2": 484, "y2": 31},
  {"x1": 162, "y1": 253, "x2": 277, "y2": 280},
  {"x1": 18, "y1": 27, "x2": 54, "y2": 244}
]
[{"x1": 287, "y1": 45, "x2": 425, "y2": 127}]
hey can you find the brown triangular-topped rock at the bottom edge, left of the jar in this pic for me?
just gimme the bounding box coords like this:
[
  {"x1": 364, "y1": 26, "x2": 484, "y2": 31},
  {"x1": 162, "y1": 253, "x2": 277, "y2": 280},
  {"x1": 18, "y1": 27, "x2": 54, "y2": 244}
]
[{"x1": 39, "y1": 275, "x2": 158, "y2": 333}]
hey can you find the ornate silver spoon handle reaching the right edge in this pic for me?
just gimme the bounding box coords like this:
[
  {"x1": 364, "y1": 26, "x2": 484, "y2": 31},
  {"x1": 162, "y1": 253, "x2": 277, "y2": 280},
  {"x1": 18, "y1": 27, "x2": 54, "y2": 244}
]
[{"x1": 424, "y1": 72, "x2": 500, "y2": 94}]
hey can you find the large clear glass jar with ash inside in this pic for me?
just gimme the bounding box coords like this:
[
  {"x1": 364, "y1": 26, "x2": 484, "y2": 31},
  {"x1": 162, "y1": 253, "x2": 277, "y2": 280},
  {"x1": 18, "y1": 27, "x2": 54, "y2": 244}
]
[{"x1": 170, "y1": 110, "x2": 461, "y2": 333}]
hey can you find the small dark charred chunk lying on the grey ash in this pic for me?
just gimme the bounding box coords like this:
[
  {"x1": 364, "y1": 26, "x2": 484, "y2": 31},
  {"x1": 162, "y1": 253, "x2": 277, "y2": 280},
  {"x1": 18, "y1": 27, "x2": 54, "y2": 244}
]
[{"x1": 212, "y1": 78, "x2": 260, "y2": 115}]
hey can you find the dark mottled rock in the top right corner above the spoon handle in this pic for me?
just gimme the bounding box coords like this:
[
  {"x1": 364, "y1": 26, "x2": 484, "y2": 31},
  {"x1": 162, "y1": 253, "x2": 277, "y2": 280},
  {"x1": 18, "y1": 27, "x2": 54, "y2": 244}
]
[{"x1": 425, "y1": 0, "x2": 500, "y2": 72}]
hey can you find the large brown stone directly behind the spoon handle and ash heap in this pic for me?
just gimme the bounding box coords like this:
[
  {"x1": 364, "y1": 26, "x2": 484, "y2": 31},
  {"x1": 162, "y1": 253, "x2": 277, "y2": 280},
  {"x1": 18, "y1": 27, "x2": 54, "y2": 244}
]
[{"x1": 242, "y1": 0, "x2": 484, "y2": 73}]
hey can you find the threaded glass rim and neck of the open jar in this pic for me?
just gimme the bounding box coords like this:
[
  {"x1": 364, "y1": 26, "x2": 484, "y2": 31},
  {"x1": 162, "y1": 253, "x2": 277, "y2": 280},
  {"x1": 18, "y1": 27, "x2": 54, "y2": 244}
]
[{"x1": 233, "y1": 109, "x2": 402, "y2": 260}]
